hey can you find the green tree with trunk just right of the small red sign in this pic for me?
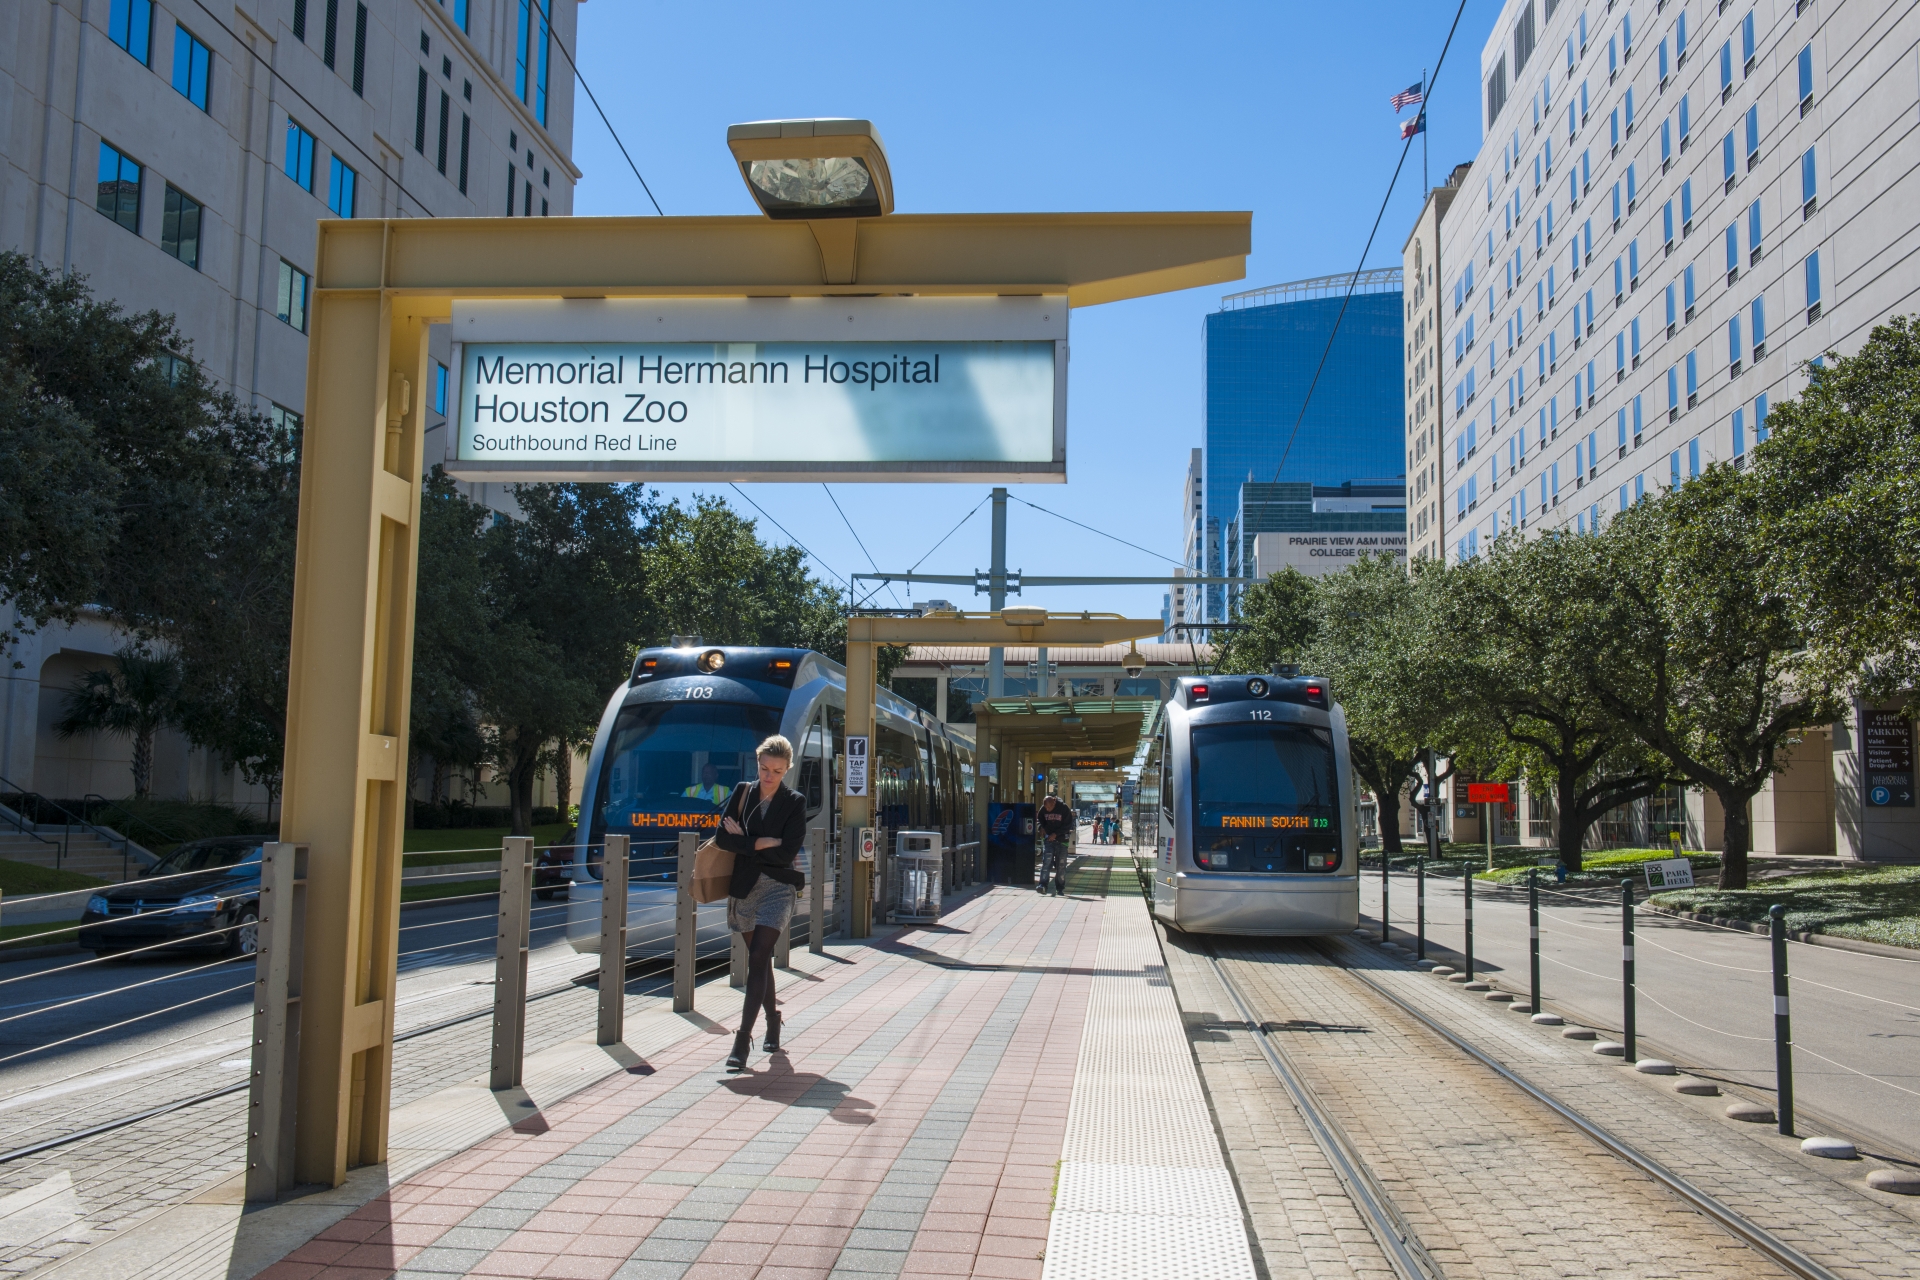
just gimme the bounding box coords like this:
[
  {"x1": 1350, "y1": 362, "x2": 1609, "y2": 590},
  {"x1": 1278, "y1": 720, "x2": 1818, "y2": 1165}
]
[{"x1": 1440, "y1": 533, "x2": 1678, "y2": 871}]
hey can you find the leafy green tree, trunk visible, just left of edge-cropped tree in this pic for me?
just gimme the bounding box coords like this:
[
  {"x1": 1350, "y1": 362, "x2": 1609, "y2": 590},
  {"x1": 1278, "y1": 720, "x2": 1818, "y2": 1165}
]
[{"x1": 1576, "y1": 464, "x2": 1843, "y2": 889}]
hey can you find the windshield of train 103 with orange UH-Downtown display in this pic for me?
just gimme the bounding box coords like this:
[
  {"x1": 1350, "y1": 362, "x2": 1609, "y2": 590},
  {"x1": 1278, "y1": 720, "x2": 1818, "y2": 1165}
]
[{"x1": 589, "y1": 702, "x2": 780, "y2": 842}]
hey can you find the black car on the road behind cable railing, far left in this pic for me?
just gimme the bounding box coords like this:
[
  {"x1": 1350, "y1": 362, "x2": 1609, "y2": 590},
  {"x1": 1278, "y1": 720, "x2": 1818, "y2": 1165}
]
[{"x1": 81, "y1": 835, "x2": 275, "y2": 956}]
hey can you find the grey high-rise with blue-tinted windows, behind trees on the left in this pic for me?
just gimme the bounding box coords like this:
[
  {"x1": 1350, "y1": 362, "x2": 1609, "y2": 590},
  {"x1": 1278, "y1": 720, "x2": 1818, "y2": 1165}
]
[{"x1": 0, "y1": 0, "x2": 580, "y2": 802}]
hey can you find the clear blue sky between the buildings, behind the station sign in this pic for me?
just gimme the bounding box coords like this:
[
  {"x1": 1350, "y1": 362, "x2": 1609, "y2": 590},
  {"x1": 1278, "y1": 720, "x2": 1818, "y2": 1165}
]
[{"x1": 574, "y1": 0, "x2": 1500, "y2": 616}]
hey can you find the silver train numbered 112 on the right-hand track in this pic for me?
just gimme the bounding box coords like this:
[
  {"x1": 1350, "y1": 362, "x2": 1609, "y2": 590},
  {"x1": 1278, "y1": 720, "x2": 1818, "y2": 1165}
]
[{"x1": 1142, "y1": 668, "x2": 1359, "y2": 936}]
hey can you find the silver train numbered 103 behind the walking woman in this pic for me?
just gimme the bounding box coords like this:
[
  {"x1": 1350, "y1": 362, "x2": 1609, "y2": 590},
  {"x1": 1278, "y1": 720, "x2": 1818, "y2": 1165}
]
[{"x1": 566, "y1": 645, "x2": 973, "y2": 958}]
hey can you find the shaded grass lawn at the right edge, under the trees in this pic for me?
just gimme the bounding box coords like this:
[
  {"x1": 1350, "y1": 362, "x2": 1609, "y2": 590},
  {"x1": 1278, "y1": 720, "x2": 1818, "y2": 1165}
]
[{"x1": 1651, "y1": 867, "x2": 1920, "y2": 948}]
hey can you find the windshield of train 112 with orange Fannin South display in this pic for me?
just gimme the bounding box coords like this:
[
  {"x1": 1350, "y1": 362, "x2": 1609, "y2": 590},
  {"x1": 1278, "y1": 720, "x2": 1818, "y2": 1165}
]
[{"x1": 1192, "y1": 722, "x2": 1340, "y2": 873}]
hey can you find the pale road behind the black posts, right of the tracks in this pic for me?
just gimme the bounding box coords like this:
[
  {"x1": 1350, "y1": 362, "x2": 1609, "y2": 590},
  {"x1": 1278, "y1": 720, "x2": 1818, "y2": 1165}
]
[{"x1": 1359, "y1": 869, "x2": 1920, "y2": 1159}]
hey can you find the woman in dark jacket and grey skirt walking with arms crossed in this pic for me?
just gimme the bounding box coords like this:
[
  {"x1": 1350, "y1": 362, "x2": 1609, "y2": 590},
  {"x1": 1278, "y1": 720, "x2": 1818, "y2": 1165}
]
[{"x1": 714, "y1": 733, "x2": 806, "y2": 1071}]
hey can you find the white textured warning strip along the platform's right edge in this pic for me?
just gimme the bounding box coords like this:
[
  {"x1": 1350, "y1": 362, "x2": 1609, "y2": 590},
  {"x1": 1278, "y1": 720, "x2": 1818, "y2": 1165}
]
[{"x1": 1043, "y1": 882, "x2": 1256, "y2": 1280}]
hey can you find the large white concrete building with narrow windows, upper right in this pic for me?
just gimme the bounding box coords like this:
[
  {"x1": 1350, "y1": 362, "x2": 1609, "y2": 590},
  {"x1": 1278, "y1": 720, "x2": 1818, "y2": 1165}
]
[{"x1": 1436, "y1": 0, "x2": 1920, "y2": 858}]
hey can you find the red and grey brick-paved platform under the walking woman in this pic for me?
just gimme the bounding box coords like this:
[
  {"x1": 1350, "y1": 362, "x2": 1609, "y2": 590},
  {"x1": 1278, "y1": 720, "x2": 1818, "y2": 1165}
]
[{"x1": 236, "y1": 877, "x2": 1152, "y2": 1280}]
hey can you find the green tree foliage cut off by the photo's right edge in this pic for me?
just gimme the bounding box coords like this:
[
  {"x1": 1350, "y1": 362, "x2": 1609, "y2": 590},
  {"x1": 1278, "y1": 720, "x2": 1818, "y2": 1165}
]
[{"x1": 1751, "y1": 317, "x2": 1920, "y2": 699}]
